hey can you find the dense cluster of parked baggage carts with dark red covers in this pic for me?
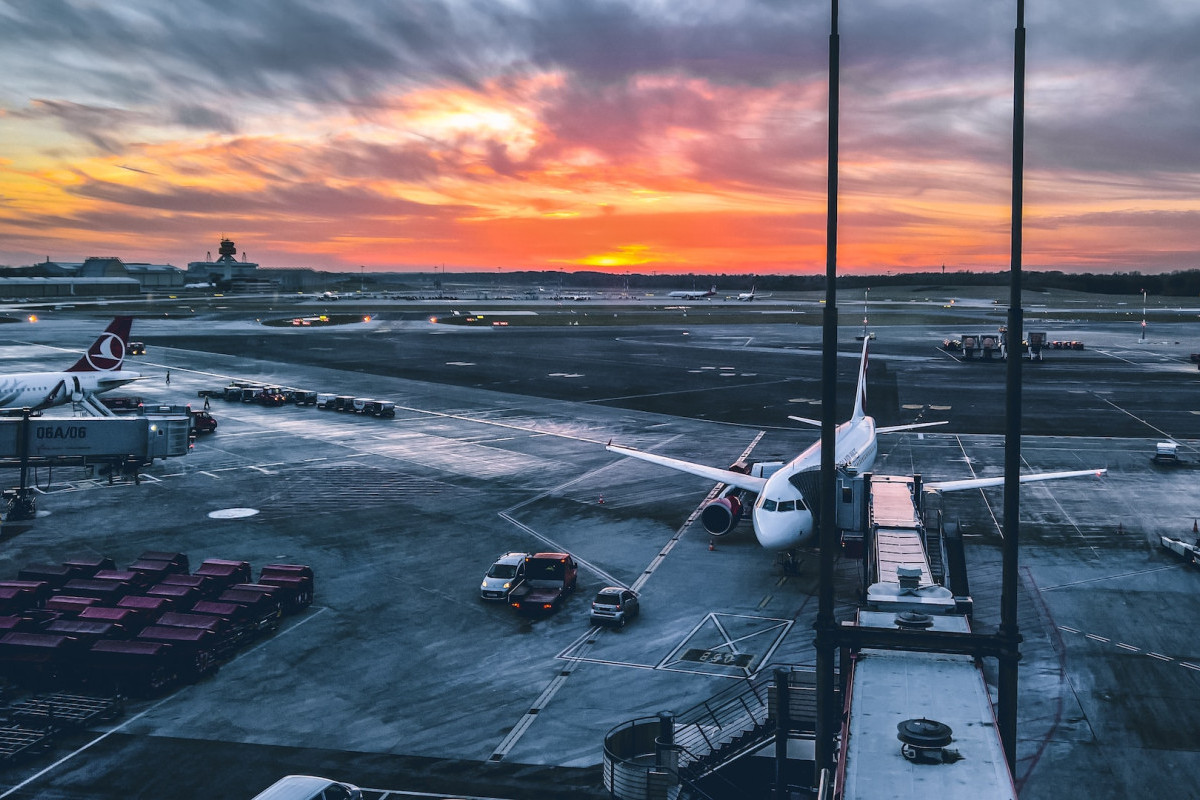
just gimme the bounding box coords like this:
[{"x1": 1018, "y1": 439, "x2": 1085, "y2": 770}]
[{"x1": 0, "y1": 552, "x2": 313, "y2": 694}]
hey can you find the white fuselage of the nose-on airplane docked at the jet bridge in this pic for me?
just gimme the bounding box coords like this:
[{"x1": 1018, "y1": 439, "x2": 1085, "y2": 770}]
[{"x1": 751, "y1": 416, "x2": 878, "y2": 551}]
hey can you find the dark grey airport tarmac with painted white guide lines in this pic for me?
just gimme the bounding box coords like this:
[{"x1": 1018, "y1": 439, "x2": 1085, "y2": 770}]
[{"x1": 0, "y1": 303, "x2": 1200, "y2": 800}]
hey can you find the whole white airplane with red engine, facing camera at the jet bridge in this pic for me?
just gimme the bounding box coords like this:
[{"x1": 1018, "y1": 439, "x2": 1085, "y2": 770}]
[{"x1": 606, "y1": 339, "x2": 1108, "y2": 551}]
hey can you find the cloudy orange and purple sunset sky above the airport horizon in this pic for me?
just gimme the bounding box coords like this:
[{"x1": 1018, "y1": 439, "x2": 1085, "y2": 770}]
[{"x1": 0, "y1": 0, "x2": 1200, "y2": 273}]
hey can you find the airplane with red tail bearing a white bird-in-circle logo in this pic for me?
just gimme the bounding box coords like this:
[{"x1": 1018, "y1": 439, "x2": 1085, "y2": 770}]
[{"x1": 0, "y1": 317, "x2": 142, "y2": 409}]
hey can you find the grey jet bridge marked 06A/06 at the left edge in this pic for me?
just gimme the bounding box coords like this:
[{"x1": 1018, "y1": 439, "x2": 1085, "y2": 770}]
[{"x1": 0, "y1": 413, "x2": 192, "y2": 522}]
